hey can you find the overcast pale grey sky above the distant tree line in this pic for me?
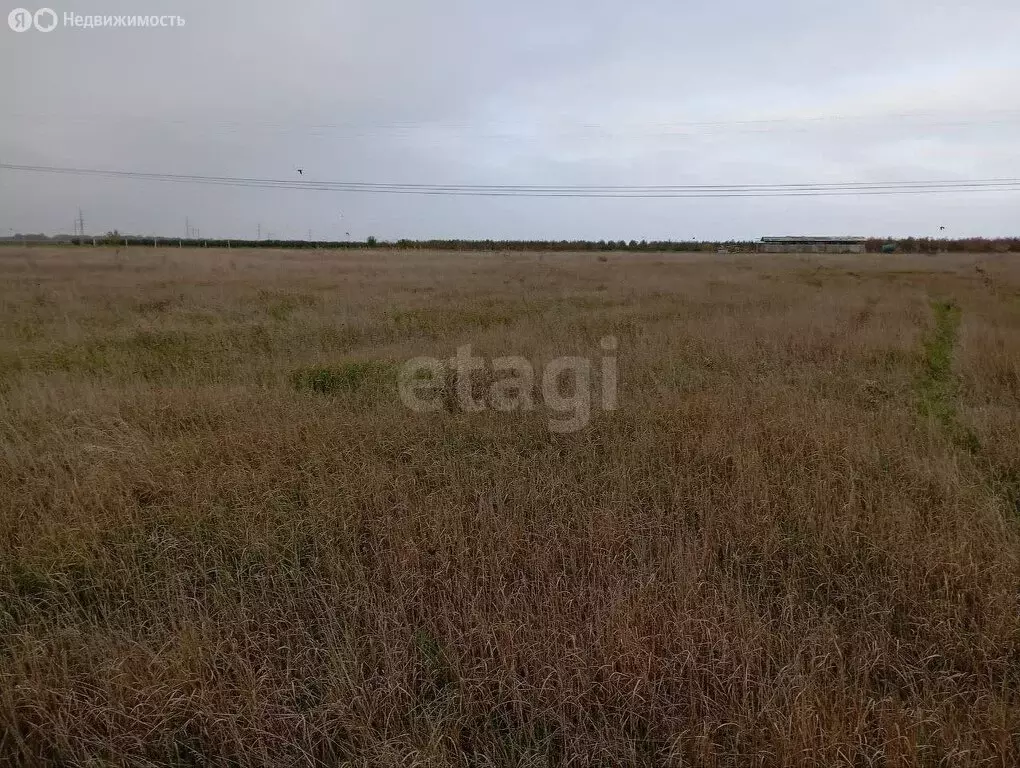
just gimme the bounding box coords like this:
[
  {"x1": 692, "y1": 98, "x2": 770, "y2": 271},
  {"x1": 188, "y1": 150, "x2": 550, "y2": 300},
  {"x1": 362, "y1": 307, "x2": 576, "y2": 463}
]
[{"x1": 0, "y1": 0, "x2": 1020, "y2": 240}]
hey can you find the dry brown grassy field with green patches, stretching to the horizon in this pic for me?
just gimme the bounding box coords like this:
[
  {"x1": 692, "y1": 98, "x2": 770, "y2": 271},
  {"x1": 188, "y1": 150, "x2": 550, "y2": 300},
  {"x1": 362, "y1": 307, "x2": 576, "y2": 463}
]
[{"x1": 0, "y1": 247, "x2": 1020, "y2": 767}]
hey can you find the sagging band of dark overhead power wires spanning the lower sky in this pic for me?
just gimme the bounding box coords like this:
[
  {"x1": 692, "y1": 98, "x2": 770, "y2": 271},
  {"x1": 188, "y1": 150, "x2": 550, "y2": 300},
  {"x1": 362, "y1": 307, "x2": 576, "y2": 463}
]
[{"x1": 0, "y1": 163, "x2": 1020, "y2": 199}]
